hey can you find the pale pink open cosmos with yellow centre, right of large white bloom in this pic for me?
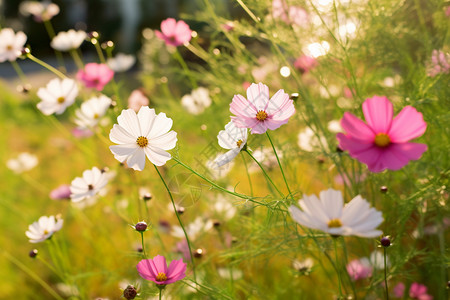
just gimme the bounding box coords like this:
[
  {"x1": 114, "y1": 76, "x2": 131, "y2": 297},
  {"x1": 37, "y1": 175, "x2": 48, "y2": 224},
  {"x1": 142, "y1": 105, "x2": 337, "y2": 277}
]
[{"x1": 230, "y1": 83, "x2": 295, "y2": 134}]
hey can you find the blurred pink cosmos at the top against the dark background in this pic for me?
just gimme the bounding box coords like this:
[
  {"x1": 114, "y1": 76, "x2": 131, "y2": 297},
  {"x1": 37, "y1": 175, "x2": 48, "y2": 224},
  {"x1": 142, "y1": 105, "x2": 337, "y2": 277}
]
[{"x1": 155, "y1": 18, "x2": 192, "y2": 47}]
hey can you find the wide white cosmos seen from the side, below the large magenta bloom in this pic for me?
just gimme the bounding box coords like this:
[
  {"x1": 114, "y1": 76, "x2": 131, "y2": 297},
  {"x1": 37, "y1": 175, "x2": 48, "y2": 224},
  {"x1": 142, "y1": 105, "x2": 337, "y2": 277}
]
[{"x1": 289, "y1": 189, "x2": 383, "y2": 238}]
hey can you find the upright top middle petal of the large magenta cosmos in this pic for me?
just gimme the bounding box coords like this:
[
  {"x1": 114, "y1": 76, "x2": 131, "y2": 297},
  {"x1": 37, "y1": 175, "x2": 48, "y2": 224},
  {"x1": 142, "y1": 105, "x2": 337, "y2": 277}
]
[{"x1": 362, "y1": 96, "x2": 393, "y2": 134}]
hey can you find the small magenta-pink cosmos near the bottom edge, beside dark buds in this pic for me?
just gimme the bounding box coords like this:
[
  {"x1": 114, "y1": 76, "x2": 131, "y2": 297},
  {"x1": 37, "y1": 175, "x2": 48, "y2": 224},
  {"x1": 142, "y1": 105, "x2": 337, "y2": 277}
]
[{"x1": 136, "y1": 255, "x2": 186, "y2": 285}]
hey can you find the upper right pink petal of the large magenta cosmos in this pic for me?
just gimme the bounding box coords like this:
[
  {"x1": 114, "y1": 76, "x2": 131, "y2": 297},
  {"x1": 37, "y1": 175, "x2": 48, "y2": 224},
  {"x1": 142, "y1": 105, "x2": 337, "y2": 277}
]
[{"x1": 389, "y1": 106, "x2": 427, "y2": 143}]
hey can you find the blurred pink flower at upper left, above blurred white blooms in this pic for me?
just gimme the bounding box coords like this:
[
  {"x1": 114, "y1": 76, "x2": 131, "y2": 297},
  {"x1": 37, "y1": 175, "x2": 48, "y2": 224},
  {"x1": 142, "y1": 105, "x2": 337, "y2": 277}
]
[{"x1": 77, "y1": 63, "x2": 114, "y2": 91}]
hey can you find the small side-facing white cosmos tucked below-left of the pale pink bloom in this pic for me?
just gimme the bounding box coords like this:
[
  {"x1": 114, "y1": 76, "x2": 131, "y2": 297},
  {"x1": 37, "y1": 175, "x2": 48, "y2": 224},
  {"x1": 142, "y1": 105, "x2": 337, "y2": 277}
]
[{"x1": 214, "y1": 121, "x2": 248, "y2": 167}]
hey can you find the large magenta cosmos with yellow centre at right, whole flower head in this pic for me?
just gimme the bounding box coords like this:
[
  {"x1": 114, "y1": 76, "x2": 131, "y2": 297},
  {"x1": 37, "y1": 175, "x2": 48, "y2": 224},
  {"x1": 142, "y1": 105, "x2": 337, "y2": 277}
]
[{"x1": 337, "y1": 96, "x2": 427, "y2": 172}]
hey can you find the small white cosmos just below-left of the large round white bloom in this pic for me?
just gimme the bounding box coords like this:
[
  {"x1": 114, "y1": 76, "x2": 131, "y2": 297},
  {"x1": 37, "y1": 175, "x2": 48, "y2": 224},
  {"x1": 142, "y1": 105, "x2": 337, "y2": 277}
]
[{"x1": 70, "y1": 167, "x2": 108, "y2": 202}]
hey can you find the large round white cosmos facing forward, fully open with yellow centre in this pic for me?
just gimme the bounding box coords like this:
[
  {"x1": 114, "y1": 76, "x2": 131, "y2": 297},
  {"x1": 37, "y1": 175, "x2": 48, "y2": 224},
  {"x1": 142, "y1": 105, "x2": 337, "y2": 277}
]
[{"x1": 109, "y1": 106, "x2": 177, "y2": 171}]
